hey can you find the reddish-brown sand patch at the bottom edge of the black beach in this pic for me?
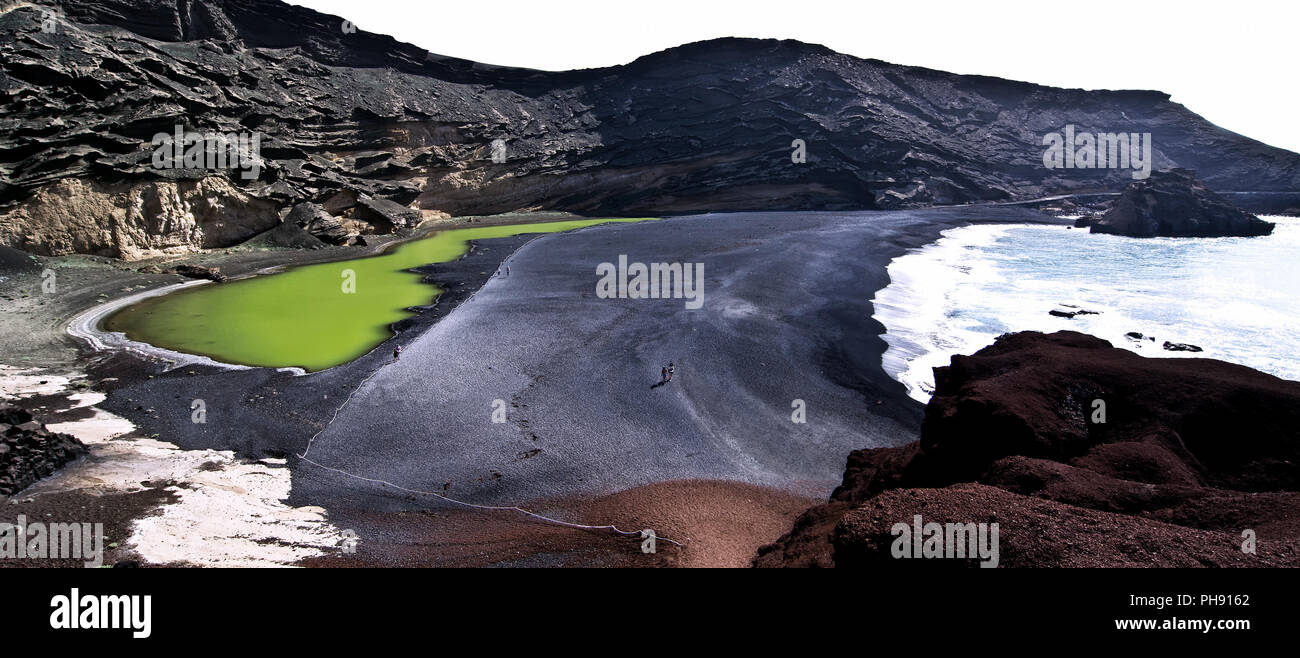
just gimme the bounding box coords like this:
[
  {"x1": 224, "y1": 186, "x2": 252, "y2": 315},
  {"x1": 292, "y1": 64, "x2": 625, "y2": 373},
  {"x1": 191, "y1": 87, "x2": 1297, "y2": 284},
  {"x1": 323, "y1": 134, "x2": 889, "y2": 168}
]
[{"x1": 300, "y1": 480, "x2": 815, "y2": 567}]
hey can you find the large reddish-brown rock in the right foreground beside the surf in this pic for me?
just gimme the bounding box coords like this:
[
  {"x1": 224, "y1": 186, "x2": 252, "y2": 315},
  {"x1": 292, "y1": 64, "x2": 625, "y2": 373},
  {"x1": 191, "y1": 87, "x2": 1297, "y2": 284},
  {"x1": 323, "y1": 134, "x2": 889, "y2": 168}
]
[{"x1": 755, "y1": 332, "x2": 1300, "y2": 566}]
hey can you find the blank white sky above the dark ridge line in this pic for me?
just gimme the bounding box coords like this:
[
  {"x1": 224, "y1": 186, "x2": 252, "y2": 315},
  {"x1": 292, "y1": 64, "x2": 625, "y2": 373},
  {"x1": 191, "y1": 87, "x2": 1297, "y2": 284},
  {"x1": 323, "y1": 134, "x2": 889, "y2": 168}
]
[{"x1": 289, "y1": 0, "x2": 1300, "y2": 152}]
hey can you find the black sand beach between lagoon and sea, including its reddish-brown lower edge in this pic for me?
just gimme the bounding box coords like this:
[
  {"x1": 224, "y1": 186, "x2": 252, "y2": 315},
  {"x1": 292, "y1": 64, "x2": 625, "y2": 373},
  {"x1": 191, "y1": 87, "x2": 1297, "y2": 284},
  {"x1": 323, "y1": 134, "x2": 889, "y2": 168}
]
[{"x1": 10, "y1": 207, "x2": 1065, "y2": 566}]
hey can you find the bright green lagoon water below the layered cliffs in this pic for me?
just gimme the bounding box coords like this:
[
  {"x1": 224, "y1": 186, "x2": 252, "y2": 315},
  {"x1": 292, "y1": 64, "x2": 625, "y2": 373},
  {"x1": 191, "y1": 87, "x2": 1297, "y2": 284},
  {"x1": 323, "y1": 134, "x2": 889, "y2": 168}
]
[{"x1": 105, "y1": 218, "x2": 642, "y2": 371}]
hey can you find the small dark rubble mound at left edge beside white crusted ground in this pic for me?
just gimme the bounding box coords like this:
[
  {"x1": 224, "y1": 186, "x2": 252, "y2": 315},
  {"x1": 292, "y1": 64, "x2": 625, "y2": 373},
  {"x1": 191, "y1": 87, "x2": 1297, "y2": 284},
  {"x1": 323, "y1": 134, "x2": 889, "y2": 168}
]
[{"x1": 0, "y1": 403, "x2": 86, "y2": 495}]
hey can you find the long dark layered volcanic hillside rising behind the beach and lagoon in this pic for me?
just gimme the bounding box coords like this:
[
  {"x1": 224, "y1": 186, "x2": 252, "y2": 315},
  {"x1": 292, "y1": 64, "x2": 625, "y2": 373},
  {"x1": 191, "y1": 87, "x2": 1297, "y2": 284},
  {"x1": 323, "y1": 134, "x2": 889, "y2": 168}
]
[{"x1": 0, "y1": 0, "x2": 1300, "y2": 257}]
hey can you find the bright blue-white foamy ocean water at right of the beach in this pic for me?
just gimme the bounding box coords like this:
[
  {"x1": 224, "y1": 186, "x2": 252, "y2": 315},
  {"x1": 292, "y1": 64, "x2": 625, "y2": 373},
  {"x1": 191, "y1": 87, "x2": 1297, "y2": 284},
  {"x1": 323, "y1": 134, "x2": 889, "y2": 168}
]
[{"x1": 872, "y1": 217, "x2": 1300, "y2": 402}]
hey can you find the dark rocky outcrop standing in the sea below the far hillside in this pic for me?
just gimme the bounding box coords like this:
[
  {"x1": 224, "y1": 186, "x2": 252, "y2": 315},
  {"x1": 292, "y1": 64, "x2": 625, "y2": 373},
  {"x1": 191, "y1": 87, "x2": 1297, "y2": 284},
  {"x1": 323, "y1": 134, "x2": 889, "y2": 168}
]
[{"x1": 1091, "y1": 169, "x2": 1273, "y2": 238}]
